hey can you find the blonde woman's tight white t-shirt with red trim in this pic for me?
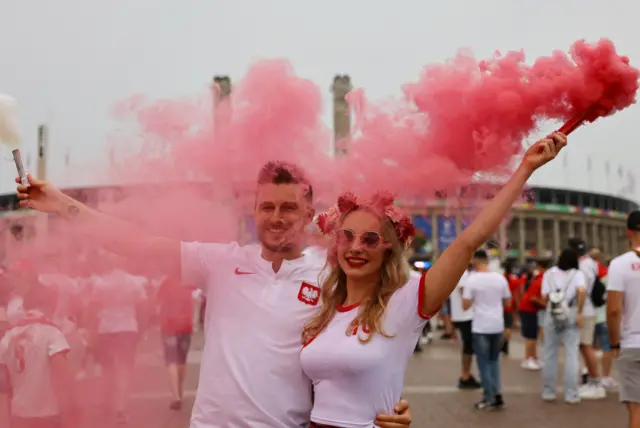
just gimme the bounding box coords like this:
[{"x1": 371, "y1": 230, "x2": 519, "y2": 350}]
[{"x1": 300, "y1": 276, "x2": 428, "y2": 428}]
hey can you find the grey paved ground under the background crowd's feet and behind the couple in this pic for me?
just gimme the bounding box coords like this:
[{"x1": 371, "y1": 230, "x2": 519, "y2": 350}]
[{"x1": 0, "y1": 330, "x2": 627, "y2": 428}]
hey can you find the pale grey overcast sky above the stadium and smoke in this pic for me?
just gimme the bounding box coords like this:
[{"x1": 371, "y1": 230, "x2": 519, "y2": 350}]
[{"x1": 0, "y1": 0, "x2": 640, "y2": 200}]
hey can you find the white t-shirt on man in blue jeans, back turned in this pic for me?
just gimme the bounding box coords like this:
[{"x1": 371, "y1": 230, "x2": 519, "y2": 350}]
[{"x1": 462, "y1": 272, "x2": 511, "y2": 334}]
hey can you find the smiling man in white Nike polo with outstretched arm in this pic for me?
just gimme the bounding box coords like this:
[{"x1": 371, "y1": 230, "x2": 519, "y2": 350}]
[{"x1": 18, "y1": 162, "x2": 411, "y2": 428}]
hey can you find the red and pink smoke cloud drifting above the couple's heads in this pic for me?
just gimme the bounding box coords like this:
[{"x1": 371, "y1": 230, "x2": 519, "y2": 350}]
[{"x1": 2, "y1": 40, "x2": 639, "y2": 428}]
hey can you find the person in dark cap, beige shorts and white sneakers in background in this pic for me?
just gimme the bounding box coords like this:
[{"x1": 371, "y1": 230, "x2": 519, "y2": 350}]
[{"x1": 569, "y1": 238, "x2": 607, "y2": 400}]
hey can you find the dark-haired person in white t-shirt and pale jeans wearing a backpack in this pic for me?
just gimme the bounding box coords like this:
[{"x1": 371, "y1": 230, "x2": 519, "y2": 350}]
[{"x1": 542, "y1": 248, "x2": 587, "y2": 404}]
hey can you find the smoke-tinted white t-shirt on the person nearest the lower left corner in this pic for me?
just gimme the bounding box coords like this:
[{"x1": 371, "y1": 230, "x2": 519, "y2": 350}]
[{"x1": 0, "y1": 313, "x2": 69, "y2": 418}]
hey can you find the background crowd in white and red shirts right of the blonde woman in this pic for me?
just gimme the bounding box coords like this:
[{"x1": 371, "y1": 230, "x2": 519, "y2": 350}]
[{"x1": 414, "y1": 221, "x2": 640, "y2": 426}]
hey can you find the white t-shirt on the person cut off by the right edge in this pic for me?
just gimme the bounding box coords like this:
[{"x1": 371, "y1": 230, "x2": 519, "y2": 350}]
[{"x1": 607, "y1": 251, "x2": 640, "y2": 348}]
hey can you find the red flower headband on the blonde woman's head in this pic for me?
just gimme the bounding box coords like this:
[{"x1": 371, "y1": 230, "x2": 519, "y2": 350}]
[{"x1": 316, "y1": 192, "x2": 416, "y2": 248}]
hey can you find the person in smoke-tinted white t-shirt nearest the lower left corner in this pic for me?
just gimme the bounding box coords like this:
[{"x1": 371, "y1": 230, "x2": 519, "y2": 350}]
[{"x1": 0, "y1": 285, "x2": 74, "y2": 428}]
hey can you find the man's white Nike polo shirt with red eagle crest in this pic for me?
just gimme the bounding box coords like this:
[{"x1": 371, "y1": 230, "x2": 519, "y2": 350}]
[{"x1": 182, "y1": 243, "x2": 324, "y2": 428}]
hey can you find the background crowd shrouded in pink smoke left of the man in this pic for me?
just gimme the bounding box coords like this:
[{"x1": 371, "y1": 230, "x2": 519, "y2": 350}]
[{"x1": 0, "y1": 249, "x2": 203, "y2": 428}]
